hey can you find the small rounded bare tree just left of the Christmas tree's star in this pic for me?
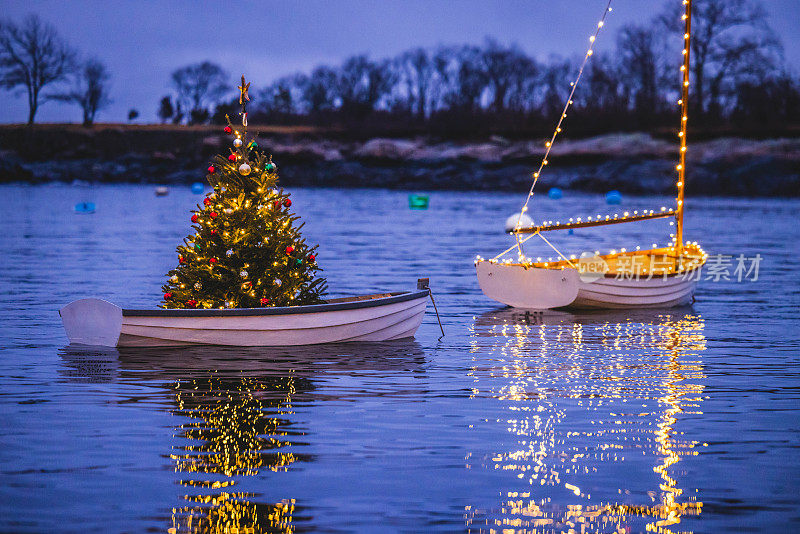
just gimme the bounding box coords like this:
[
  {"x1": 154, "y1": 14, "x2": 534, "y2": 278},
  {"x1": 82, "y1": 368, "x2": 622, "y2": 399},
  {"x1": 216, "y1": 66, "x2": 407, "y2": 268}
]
[{"x1": 172, "y1": 61, "x2": 230, "y2": 125}]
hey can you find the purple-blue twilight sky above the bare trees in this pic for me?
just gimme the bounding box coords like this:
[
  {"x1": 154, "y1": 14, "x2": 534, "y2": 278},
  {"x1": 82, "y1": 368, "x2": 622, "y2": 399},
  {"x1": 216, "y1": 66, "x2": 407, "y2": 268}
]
[{"x1": 0, "y1": 0, "x2": 800, "y2": 122}]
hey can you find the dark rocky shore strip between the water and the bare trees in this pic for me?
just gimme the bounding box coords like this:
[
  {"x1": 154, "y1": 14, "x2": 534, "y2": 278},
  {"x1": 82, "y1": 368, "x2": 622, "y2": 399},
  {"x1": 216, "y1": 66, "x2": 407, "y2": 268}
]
[{"x1": 0, "y1": 125, "x2": 800, "y2": 197}]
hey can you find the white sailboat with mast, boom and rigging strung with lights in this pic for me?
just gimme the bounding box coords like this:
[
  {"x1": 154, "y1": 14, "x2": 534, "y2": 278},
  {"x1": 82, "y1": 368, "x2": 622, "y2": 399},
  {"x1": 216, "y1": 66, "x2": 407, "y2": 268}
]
[{"x1": 475, "y1": 0, "x2": 708, "y2": 310}]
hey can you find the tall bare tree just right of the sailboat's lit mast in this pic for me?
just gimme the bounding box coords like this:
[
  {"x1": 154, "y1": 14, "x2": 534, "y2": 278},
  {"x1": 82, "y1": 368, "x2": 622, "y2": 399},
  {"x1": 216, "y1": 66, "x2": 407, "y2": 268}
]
[{"x1": 658, "y1": 0, "x2": 782, "y2": 115}]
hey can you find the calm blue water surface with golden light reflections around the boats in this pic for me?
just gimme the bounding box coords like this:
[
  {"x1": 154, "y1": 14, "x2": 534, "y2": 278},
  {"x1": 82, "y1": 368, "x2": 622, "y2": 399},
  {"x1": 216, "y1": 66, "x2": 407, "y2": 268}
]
[{"x1": 0, "y1": 186, "x2": 800, "y2": 532}]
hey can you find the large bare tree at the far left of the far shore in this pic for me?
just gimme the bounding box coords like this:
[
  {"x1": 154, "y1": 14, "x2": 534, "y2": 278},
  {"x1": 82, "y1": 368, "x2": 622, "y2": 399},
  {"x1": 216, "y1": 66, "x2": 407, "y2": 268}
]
[{"x1": 0, "y1": 15, "x2": 75, "y2": 124}]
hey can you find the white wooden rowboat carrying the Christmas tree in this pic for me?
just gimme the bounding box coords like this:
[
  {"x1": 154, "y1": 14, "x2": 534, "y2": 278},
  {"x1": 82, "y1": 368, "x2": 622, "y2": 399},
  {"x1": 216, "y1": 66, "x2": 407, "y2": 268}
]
[{"x1": 59, "y1": 287, "x2": 430, "y2": 347}]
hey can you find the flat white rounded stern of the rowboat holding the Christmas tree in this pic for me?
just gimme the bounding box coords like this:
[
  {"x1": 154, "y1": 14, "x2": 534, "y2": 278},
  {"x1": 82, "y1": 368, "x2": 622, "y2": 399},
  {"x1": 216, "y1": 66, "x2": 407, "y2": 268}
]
[{"x1": 58, "y1": 299, "x2": 122, "y2": 347}]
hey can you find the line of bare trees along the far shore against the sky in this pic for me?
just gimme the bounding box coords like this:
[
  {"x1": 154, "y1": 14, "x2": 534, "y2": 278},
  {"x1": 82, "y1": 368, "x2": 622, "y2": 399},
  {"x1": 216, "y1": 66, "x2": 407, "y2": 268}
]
[{"x1": 0, "y1": 0, "x2": 800, "y2": 135}]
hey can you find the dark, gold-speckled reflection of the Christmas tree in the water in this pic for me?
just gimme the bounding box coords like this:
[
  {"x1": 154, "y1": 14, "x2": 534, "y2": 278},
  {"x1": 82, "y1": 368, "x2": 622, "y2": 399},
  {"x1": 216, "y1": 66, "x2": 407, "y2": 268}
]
[{"x1": 169, "y1": 376, "x2": 310, "y2": 533}]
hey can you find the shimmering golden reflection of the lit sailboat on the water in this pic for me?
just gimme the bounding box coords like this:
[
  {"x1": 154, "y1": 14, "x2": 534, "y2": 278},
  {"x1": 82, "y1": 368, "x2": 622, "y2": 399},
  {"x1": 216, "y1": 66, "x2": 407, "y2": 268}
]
[{"x1": 465, "y1": 311, "x2": 705, "y2": 533}]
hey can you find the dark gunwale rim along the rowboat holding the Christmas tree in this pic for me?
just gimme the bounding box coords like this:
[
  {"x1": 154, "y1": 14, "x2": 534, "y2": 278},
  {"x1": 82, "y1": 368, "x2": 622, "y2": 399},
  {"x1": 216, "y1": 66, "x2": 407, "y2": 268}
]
[{"x1": 122, "y1": 289, "x2": 430, "y2": 317}]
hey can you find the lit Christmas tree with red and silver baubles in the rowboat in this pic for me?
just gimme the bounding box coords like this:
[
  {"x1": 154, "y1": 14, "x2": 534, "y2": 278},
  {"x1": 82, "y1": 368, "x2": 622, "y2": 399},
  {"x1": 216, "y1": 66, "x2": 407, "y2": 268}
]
[{"x1": 162, "y1": 76, "x2": 326, "y2": 308}]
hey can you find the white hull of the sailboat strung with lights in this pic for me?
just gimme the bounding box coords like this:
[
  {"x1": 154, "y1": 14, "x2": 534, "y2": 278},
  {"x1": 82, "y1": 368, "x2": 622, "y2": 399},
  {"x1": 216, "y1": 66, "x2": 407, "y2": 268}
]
[{"x1": 475, "y1": 261, "x2": 697, "y2": 310}]
